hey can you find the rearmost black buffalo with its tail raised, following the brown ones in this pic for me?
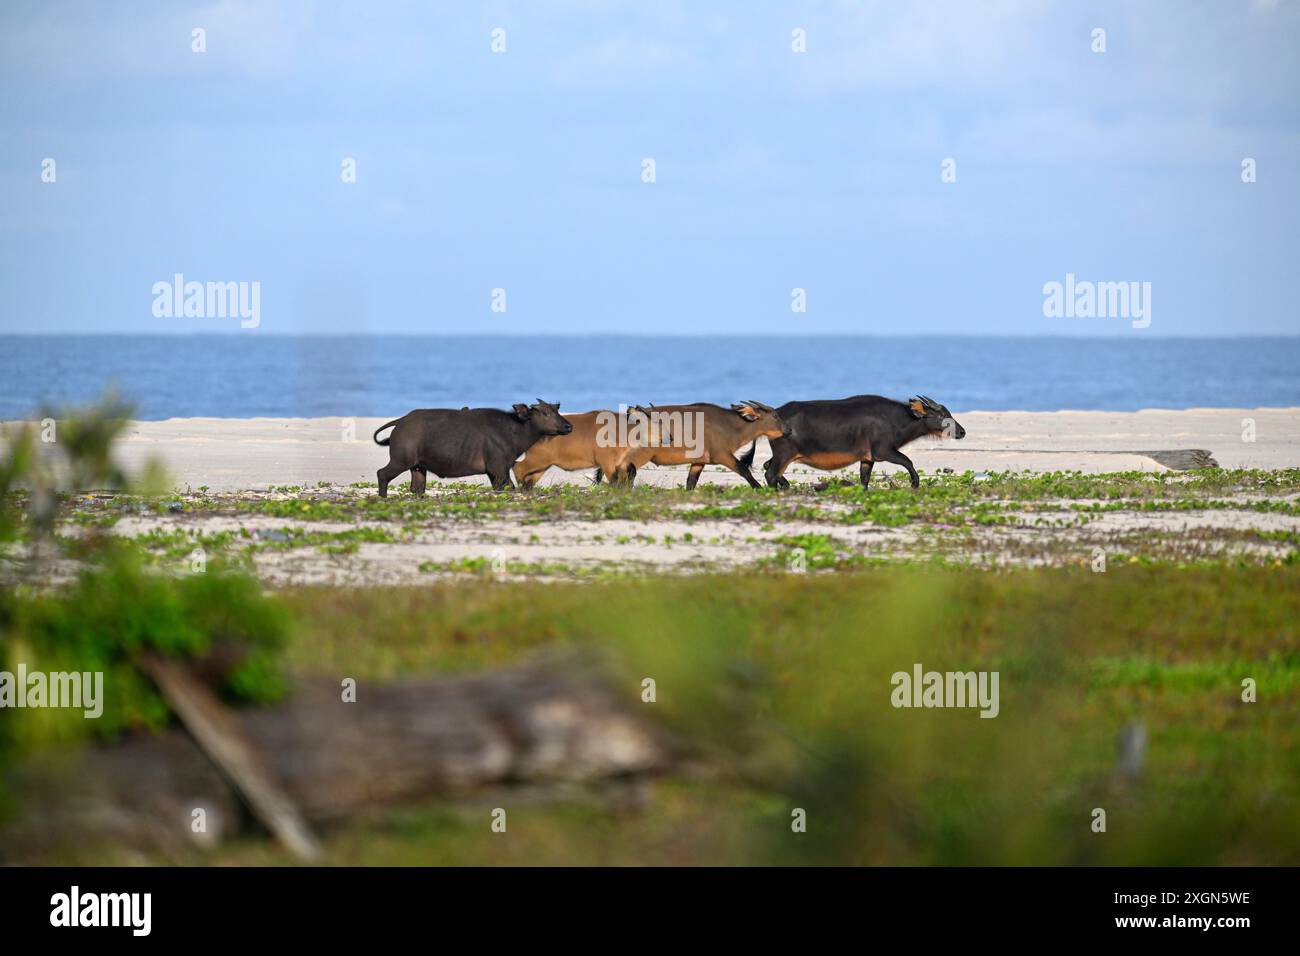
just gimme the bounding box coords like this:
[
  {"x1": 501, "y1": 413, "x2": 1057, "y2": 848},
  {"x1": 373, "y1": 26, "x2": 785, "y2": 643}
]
[{"x1": 374, "y1": 398, "x2": 573, "y2": 498}]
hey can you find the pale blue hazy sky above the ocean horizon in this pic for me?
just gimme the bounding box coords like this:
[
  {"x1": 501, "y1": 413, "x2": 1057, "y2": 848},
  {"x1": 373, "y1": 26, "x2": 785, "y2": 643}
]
[{"x1": 0, "y1": 0, "x2": 1300, "y2": 336}]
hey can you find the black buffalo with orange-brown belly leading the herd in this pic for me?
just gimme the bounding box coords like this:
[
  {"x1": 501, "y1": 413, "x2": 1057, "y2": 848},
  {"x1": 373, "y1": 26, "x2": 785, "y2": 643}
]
[{"x1": 745, "y1": 395, "x2": 966, "y2": 488}]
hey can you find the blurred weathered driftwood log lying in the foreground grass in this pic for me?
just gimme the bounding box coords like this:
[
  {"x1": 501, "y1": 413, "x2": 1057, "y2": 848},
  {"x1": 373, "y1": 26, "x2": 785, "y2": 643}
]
[{"x1": 0, "y1": 666, "x2": 673, "y2": 860}]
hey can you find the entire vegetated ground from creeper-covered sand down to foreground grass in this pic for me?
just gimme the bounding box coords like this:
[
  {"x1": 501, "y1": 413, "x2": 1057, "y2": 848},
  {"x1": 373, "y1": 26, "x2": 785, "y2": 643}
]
[{"x1": 2, "y1": 470, "x2": 1300, "y2": 865}]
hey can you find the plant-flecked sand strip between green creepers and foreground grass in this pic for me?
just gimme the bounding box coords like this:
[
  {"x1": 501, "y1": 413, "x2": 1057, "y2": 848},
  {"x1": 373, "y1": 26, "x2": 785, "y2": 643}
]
[{"x1": 98, "y1": 493, "x2": 1300, "y2": 587}]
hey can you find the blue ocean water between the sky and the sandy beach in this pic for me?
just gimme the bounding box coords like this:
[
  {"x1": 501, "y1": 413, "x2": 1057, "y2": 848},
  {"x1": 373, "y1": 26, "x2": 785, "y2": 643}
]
[{"x1": 0, "y1": 332, "x2": 1300, "y2": 419}]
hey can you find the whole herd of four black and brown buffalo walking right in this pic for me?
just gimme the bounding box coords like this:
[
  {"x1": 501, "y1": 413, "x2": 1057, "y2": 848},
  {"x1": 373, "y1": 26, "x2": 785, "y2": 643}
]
[{"x1": 374, "y1": 395, "x2": 966, "y2": 497}]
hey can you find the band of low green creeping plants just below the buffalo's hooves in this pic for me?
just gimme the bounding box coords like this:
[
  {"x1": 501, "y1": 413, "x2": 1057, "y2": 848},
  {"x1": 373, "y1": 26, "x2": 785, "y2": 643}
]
[{"x1": 55, "y1": 468, "x2": 1300, "y2": 527}]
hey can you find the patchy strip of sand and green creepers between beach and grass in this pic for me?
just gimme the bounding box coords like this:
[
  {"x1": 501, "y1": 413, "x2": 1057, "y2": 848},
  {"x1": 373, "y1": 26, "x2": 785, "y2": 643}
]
[{"x1": 45, "y1": 470, "x2": 1300, "y2": 587}]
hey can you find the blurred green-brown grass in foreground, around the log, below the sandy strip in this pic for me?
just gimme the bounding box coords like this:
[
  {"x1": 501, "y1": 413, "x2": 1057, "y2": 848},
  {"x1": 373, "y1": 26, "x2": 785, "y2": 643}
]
[{"x1": 48, "y1": 567, "x2": 1300, "y2": 865}]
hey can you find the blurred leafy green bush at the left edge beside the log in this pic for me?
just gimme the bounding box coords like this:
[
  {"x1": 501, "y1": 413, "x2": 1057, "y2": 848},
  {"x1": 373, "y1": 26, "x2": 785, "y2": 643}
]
[{"x1": 0, "y1": 395, "x2": 290, "y2": 801}]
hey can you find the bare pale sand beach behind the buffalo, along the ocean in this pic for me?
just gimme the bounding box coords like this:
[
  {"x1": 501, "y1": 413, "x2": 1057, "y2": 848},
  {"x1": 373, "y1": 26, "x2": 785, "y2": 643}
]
[{"x1": 5, "y1": 408, "x2": 1300, "y2": 490}]
